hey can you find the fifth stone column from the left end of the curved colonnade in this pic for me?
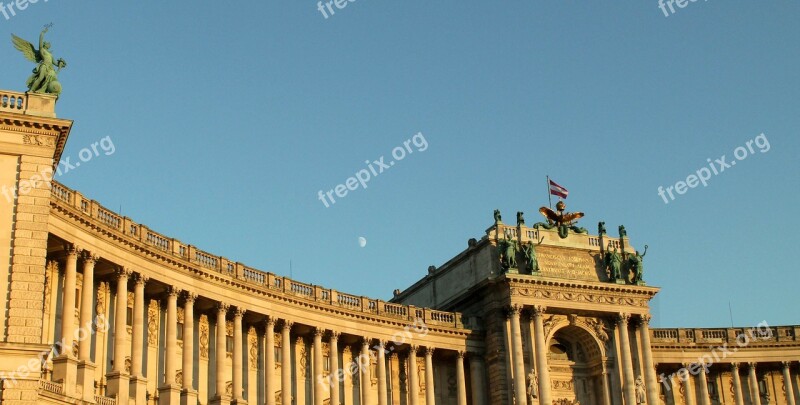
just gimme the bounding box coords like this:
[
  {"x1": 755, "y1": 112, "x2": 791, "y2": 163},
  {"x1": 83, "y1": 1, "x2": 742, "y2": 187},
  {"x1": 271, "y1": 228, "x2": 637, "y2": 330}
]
[{"x1": 158, "y1": 286, "x2": 181, "y2": 405}]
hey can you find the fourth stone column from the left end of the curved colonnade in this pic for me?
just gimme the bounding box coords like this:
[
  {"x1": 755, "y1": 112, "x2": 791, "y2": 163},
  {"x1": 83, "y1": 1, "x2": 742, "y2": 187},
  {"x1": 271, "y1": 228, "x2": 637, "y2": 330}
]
[{"x1": 129, "y1": 273, "x2": 149, "y2": 405}]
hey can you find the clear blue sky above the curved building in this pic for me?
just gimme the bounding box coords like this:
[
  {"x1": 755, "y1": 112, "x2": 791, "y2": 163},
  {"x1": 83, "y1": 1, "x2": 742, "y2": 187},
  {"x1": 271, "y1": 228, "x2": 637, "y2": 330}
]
[{"x1": 0, "y1": 0, "x2": 800, "y2": 327}]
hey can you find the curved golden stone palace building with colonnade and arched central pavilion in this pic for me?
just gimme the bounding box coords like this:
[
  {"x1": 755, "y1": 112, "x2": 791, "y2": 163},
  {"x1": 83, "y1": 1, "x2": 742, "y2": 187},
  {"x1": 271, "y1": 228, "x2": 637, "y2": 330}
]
[{"x1": 0, "y1": 91, "x2": 800, "y2": 405}]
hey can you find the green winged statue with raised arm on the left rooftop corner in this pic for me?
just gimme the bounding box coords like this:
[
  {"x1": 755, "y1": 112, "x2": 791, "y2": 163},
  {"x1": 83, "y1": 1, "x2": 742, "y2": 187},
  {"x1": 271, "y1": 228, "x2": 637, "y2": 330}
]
[{"x1": 11, "y1": 24, "x2": 67, "y2": 97}]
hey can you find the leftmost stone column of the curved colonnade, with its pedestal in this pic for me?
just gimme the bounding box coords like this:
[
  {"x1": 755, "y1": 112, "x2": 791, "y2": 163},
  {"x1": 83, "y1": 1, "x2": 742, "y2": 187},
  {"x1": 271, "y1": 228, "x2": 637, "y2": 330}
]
[{"x1": 53, "y1": 245, "x2": 80, "y2": 396}]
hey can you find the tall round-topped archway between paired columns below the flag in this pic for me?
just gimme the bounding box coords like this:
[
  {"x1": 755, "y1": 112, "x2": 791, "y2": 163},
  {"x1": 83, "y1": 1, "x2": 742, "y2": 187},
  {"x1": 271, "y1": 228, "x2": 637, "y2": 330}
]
[{"x1": 547, "y1": 325, "x2": 604, "y2": 405}]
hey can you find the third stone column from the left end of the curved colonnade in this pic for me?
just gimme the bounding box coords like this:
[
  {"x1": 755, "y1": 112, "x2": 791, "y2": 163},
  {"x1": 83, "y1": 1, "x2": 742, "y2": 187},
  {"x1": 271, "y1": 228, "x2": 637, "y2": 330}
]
[{"x1": 106, "y1": 267, "x2": 131, "y2": 402}]
